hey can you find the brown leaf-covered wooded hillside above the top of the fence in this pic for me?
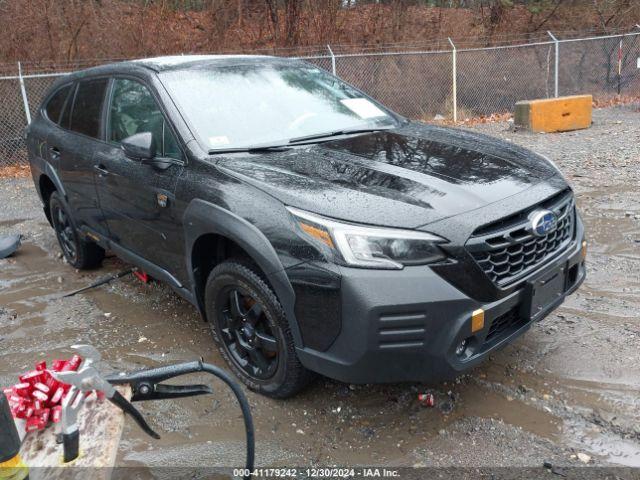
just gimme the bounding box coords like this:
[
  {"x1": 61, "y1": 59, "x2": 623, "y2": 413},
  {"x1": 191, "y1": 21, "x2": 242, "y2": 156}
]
[{"x1": 0, "y1": 0, "x2": 640, "y2": 62}]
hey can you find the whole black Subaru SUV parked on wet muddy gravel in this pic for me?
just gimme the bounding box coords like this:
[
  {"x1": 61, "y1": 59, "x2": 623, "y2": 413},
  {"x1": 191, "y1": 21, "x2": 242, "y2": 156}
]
[{"x1": 27, "y1": 56, "x2": 586, "y2": 397}]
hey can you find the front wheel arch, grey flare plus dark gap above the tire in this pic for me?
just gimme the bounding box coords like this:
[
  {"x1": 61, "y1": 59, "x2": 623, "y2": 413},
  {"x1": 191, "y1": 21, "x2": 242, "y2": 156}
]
[{"x1": 183, "y1": 199, "x2": 302, "y2": 345}]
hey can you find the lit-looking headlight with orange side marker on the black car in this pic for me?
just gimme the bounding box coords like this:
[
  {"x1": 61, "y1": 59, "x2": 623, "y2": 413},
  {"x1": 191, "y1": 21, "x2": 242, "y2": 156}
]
[{"x1": 287, "y1": 207, "x2": 446, "y2": 269}]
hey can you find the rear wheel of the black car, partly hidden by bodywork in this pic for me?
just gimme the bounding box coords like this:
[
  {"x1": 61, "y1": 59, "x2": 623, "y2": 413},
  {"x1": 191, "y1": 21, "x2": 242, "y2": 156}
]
[{"x1": 49, "y1": 192, "x2": 104, "y2": 270}]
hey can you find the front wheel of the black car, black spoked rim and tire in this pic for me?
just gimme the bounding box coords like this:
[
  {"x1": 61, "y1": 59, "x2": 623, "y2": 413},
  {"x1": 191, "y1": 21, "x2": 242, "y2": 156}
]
[{"x1": 205, "y1": 260, "x2": 313, "y2": 398}]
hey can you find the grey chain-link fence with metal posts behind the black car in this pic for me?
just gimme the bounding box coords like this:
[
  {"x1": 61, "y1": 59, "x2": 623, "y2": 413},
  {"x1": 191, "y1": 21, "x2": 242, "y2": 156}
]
[{"x1": 0, "y1": 32, "x2": 640, "y2": 167}]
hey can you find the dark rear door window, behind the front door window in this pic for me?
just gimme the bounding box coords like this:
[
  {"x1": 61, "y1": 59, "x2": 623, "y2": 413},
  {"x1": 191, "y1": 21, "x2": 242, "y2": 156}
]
[{"x1": 70, "y1": 78, "x2": 108, "y2": 138}]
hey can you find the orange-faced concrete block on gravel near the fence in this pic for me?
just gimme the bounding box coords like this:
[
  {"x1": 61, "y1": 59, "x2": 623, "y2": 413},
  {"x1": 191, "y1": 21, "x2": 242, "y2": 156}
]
[{"x1": 514, "y1": 95, "x2": 593, "y2": 133}]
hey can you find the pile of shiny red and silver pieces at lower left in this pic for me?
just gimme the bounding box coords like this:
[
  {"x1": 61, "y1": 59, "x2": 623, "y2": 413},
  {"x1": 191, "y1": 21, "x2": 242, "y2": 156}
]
[{"x1": 4, "y1": 355, "x2": 82, "y2": 432}]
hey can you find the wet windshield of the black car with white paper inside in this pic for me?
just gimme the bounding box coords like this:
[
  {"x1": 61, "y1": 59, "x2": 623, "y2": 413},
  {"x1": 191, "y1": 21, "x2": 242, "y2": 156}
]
[{"x1": 160, "y1": 65, "x2": 396, "y2": 150}]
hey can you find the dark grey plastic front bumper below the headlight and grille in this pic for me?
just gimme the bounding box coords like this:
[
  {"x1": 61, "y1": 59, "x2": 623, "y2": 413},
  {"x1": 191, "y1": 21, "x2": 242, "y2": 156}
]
[{"x1": 296, "y1": 220, "x2": 585, "y2": 383}]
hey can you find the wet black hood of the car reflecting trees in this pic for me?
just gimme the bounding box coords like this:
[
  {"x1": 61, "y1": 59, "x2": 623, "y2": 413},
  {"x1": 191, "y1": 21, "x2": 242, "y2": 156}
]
[{"x1": 218, "y1": 123, "x2": 558, "y2": 228}]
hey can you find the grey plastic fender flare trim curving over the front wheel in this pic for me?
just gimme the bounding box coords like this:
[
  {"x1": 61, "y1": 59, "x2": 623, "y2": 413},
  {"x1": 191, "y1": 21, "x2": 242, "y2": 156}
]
[{"x1": 183, "y1": 199, "x2": 302, "y2": 346}]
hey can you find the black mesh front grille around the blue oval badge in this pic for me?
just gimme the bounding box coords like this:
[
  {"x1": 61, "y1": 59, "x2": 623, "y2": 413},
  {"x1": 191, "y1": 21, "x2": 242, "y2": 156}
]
[{"x1": 466, "y1": 191, "x2": 575, "y2": 286}]
